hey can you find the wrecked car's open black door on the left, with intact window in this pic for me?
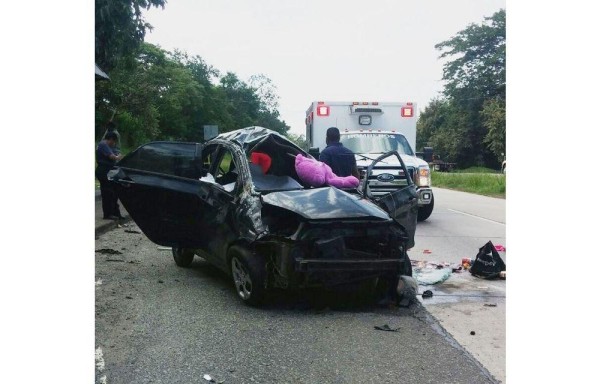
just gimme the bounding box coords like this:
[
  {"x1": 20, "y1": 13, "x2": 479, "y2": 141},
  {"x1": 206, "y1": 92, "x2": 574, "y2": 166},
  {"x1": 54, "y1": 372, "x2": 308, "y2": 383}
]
[{"x1": 108, "y1": 142, "x2": 211, "y2": 248}]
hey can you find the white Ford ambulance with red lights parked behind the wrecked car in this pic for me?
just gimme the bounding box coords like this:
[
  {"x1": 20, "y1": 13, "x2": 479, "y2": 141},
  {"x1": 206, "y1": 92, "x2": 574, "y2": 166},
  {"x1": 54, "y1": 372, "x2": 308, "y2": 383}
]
[{"x1": 305, "y1": 101, "x2": 433, "y2": 221}]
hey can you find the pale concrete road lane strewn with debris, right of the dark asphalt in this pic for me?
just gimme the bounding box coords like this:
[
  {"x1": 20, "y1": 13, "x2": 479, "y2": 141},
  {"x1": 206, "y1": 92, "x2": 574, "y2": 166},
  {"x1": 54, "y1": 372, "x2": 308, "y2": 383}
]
[{"x1": 409, "y1": 188, "x2": 509, "y2": 382}]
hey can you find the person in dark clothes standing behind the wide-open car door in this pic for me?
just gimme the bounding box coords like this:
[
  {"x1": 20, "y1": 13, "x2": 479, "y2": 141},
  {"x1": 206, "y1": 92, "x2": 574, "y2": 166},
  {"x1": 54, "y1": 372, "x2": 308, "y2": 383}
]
[{"x1": 96, "y1": 131, "x2": 123, "y2": 220}]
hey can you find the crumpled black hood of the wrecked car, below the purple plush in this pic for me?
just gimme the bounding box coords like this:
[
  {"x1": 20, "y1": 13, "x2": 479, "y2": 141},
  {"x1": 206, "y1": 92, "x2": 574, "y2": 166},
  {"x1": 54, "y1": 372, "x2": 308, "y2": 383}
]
[{"x1": 262, "y1": 187, "x2": 390, "y2": 220}]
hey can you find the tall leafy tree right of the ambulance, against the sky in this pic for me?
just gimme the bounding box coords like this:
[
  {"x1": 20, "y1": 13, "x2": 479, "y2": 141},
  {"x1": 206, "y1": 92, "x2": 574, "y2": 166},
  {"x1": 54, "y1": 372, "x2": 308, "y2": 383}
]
[{"x1": 417, "y1": 10, "x2": 506, "y2": 167}]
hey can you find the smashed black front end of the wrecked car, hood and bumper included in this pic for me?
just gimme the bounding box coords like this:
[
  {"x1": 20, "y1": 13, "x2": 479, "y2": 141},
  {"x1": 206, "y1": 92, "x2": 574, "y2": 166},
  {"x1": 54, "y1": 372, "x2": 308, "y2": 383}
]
[{"x1": 254, "y1": 187, "x2": 411, "y2": 288}]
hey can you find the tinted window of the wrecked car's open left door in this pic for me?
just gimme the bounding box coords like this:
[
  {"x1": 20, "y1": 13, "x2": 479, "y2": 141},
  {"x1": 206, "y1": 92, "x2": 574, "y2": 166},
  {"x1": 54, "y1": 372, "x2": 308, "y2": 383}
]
[{"x1": 119, "y1": 142, "x2": 202, "y2": 179}]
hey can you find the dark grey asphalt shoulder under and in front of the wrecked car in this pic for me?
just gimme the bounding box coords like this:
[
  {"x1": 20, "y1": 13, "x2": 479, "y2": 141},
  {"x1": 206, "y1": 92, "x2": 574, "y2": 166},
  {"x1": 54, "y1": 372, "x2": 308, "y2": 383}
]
[{"x1": 96, "y1": 218, "x2": 496, "y2": 383}]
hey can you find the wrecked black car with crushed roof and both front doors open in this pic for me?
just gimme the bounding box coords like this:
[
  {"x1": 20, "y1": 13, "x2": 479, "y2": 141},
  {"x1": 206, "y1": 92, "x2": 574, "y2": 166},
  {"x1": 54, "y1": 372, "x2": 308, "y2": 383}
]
[{"x1": 109, "y1": 127, "x2": 418, "y2": 304}]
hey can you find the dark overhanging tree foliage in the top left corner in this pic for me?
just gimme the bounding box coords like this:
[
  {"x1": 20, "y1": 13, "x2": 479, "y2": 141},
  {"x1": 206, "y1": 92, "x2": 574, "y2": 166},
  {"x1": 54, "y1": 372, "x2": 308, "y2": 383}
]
[{"x1": 95, "y1": 0, "x2": 167, "y2": 71}]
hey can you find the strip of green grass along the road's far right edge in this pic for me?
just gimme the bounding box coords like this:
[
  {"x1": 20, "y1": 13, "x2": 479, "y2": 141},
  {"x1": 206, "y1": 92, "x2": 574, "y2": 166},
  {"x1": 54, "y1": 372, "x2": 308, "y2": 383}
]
[{"x1": 431, "y1": 172, "x2": 506, "y2": 199}]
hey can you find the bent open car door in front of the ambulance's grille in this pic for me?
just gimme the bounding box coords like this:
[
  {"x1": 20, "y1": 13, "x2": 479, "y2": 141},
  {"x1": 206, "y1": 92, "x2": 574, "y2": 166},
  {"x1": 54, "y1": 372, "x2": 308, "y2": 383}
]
[{"x1": 362, "y1": 151, "x2": 419, "y2": 248}]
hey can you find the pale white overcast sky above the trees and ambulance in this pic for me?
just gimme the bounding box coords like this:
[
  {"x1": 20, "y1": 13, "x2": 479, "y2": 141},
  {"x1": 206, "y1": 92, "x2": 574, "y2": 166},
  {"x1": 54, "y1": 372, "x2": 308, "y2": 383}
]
[{"x1": 146, "y1": 0, "x2": 506, "y2": 134}]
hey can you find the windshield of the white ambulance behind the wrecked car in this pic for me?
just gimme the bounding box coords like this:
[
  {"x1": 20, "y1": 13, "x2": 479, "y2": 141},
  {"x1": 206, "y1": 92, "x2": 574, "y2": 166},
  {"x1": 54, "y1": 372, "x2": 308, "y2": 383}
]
[{"x1": 340, "y1": 132, "x2": 413, "y2": 156}]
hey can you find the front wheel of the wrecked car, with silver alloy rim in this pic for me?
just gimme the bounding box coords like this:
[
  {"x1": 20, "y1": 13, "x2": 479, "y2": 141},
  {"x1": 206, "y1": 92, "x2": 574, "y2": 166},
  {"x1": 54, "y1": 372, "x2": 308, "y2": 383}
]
[{"x1": 229, "y1": 246, "x2": 266, "y2": 306}]
